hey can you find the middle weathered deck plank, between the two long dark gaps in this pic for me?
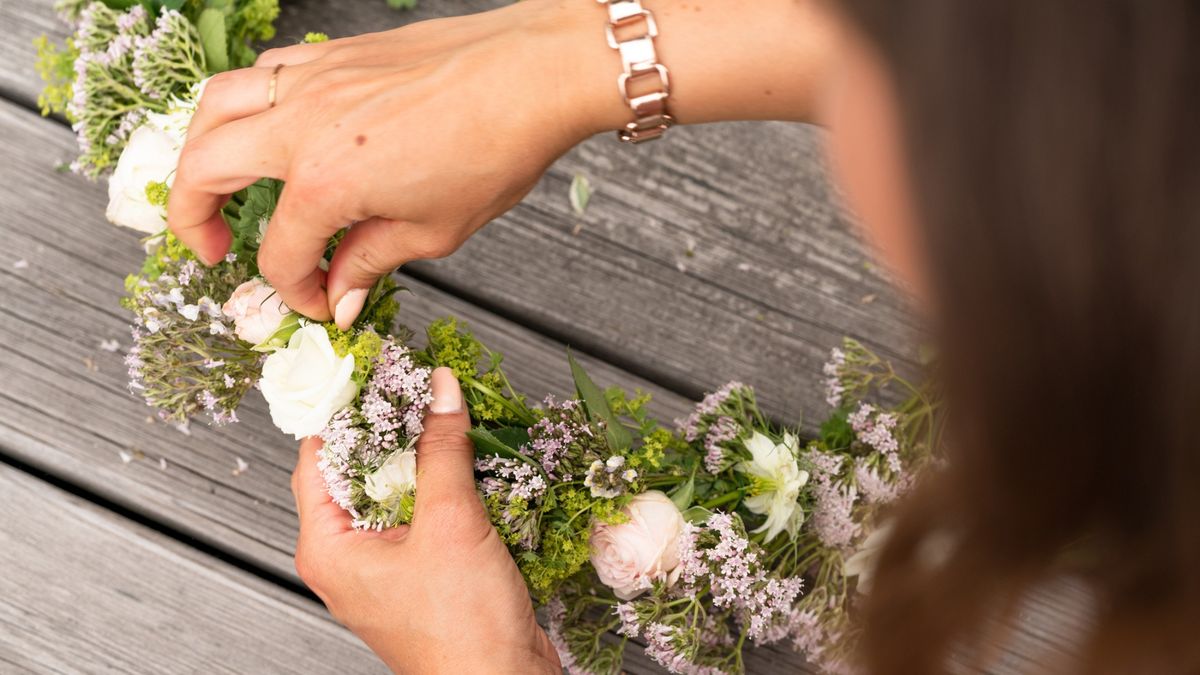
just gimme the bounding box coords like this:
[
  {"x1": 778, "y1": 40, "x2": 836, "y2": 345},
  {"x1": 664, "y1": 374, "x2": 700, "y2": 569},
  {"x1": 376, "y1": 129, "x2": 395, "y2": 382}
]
[{"x1": 0, "y1": 96, "x2": 739, "y2": 673}]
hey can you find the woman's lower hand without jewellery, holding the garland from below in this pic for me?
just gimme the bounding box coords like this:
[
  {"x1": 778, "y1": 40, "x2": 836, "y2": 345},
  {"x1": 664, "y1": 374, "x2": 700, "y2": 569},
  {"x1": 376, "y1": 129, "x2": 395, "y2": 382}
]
[{"x1": 292, "y1": 368, "x2": 562, "y2": 674}]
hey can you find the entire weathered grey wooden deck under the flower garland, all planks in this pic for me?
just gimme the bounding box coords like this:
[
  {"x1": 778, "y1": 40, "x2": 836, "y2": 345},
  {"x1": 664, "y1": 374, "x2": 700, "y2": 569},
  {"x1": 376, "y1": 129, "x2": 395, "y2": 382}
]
[{"x1": 0, "y1": 0, "x2": 1085, "y2": 674}]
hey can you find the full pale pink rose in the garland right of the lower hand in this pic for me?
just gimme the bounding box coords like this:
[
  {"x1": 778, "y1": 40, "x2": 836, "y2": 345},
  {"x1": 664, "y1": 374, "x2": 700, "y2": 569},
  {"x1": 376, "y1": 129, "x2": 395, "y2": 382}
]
[{"x1": 592, "y1": 490, "x2": 684, "y2": 601}]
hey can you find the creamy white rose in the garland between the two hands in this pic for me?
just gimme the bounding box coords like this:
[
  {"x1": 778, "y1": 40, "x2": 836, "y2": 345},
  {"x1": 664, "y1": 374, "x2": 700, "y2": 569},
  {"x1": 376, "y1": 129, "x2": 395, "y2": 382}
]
[{"x1": 259, "y1": 323, "x2": 358, "y2": 441}]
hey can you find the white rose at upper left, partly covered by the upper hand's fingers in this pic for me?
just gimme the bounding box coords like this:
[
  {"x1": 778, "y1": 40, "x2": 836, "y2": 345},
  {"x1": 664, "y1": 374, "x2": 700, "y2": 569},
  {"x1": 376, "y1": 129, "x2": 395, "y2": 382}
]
[{"x1": 104, "y1": 107, "x2": 192, "y2": 234}]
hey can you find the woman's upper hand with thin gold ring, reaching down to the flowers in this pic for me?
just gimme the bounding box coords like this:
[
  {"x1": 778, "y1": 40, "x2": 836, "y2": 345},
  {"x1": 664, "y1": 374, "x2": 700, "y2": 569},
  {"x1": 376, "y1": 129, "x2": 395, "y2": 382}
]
[{"x1": 168, "y1": 0, "x2": 622, "y2": 328}]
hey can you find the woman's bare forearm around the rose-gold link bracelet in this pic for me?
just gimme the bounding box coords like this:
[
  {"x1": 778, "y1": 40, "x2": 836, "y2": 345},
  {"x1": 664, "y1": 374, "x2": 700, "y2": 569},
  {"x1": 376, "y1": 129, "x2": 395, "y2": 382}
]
[{"x1": 540, "y1": 0, "x2": 835, "y2": 133}]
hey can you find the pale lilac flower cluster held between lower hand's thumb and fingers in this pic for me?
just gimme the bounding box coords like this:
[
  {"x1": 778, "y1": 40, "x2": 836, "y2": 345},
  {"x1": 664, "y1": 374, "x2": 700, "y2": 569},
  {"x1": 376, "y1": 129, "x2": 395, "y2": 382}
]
[{"x1": 317, "y1": 336, "x2": 433, "y2": 528}]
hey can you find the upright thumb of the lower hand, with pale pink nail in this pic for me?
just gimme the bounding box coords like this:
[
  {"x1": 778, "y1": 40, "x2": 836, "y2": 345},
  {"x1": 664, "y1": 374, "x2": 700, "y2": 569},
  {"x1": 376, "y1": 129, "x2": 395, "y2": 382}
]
[{"x1": 413, "y1": 368, "x2": 479, "y2": 526}]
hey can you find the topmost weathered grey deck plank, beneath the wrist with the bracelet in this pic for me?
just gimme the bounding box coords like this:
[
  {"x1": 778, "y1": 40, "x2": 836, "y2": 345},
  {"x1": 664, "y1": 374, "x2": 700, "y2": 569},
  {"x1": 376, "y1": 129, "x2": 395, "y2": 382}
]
[{"x1": 0, "y1": 0, "x2": 914, "y2": 422}]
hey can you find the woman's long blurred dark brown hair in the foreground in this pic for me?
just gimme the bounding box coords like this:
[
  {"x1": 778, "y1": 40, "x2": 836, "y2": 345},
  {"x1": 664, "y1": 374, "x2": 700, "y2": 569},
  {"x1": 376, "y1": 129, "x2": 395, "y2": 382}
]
[{"x1": 839, "y1": 0, "x2": 1200, "y2": 673}]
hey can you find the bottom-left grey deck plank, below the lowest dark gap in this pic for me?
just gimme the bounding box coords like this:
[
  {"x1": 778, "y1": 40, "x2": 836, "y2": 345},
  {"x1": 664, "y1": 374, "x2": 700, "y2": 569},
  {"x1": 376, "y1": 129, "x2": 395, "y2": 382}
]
[{"x1": 0, "y1": 465, "x2": 386, "y2": 674}]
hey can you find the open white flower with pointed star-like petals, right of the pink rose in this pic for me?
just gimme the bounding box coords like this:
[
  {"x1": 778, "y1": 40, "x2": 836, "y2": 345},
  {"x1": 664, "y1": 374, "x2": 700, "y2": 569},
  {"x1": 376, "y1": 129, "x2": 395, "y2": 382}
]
[{"x1": 737, "y1": 431, "x2": 809, "y2": 542}]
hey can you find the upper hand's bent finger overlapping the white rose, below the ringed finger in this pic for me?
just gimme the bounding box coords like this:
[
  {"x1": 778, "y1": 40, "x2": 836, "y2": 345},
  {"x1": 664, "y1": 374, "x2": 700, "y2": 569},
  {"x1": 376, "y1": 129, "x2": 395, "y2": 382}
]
[{"x1": 167, "y1": 108, "x2": 290, "y2": 265}]
